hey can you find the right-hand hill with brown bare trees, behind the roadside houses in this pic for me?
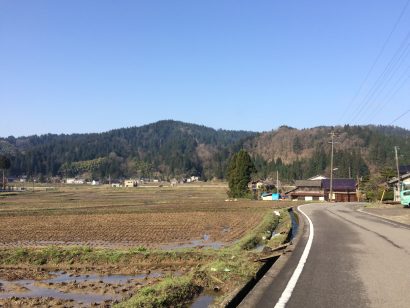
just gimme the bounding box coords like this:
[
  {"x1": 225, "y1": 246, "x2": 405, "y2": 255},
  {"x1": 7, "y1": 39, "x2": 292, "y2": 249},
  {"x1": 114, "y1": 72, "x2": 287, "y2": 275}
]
[{"x1": 244, "y1": 125, "x2": 410, "y2": 179}]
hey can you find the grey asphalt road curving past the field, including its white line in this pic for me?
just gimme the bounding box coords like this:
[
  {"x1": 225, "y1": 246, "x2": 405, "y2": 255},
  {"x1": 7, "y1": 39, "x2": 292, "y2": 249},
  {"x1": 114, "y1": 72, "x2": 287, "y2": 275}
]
[{"x1": 240, "y1": 203, "x2": 410, "y2": 308}]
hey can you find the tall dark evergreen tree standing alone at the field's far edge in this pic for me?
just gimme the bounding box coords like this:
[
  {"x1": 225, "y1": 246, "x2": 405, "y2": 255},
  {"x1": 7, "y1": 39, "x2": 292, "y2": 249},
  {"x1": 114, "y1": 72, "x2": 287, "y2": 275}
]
[{"x1": 228, "y1": 150, "x2": 256, "y2": 198}]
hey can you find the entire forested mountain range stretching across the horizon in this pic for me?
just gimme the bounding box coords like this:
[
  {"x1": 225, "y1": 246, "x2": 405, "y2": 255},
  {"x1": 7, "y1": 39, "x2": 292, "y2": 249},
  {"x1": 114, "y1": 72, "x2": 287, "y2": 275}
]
[{"x1": 0, "y1": 120, "x2": 410, "y2": 180}]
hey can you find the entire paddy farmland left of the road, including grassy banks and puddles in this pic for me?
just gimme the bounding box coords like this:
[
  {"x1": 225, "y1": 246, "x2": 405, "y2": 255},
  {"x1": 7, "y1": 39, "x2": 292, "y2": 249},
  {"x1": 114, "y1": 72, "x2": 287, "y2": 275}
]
[{"x1": 0, "y1": 183, "x2": 290, "y2": 307}]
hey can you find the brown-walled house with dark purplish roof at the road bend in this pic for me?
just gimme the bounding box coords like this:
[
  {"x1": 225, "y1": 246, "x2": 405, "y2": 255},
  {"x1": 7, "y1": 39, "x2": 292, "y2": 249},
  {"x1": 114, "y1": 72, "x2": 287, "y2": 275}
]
[{"x1": 322, "y1": 179, "x2": 357, "y2": 202}]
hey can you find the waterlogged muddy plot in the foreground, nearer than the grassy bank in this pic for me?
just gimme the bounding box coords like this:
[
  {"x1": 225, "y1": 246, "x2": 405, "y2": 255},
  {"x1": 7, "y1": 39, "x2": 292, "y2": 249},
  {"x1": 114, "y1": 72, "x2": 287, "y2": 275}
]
[{"x1": 0, "y1": 268, "x2": 164, "y2": 307}]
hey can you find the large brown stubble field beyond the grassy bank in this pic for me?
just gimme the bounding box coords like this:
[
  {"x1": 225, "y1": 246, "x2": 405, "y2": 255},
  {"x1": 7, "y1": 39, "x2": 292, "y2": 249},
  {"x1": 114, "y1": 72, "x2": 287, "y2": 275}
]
[{"x1": 0, "y1": 185, "x2": 267, "y2": 248}]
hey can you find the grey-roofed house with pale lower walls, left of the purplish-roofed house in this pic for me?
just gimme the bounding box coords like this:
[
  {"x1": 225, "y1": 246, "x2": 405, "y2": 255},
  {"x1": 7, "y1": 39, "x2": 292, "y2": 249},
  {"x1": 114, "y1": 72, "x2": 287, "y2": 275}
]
[{"x1": 287, "y1": 180, "x2": 325, "y2": 201}]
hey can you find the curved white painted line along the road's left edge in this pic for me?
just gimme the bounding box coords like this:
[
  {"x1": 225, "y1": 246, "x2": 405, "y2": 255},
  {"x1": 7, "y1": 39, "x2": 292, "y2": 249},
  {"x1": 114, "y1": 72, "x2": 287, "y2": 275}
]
[{"x1": 275, "y1": 205, "x2": 315, "y2": 308}]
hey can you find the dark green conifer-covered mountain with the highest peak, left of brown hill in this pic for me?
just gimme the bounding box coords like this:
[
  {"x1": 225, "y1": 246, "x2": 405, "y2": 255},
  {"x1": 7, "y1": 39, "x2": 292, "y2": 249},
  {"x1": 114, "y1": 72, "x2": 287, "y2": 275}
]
[{"x1": 0, "y1": 120, "x2": 256, "y2": 178}]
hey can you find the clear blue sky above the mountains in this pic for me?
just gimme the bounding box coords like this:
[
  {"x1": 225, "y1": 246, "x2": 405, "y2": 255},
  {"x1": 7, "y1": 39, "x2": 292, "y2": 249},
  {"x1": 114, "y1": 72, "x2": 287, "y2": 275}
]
[{"x1": 0, "y1": 0, "x2": 410, "y2": 137}]
